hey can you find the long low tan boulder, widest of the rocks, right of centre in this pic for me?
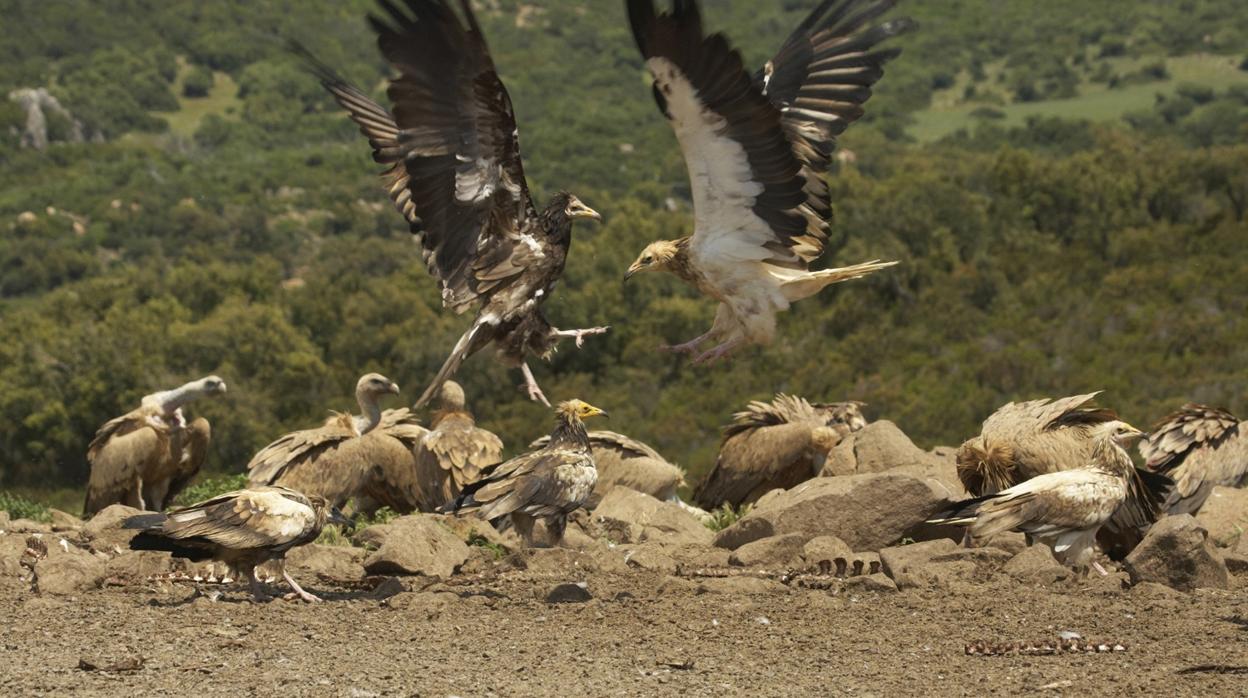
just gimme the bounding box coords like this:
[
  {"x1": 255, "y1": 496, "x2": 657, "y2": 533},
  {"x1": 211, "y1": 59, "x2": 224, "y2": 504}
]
[{"x1": 715, "y1": 472, "x2": 948, "y2": 551}]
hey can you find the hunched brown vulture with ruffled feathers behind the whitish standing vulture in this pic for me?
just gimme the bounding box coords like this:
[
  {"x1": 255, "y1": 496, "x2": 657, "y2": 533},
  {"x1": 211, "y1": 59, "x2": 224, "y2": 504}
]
[{"x1": 956, "y1": 392, "x2": 1173, "y2": 559}]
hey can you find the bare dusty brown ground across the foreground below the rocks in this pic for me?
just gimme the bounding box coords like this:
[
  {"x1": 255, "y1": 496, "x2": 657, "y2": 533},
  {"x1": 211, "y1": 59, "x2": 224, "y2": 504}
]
[{"x1": 0, "y1": 551, "x2": 1248, "y2": 697}]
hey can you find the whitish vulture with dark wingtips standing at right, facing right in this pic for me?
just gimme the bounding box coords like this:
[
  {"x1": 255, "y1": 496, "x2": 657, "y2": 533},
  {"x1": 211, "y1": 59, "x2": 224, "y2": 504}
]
[{"x1": 930, "y1": 420, "x2": 1144, "y2": 574}]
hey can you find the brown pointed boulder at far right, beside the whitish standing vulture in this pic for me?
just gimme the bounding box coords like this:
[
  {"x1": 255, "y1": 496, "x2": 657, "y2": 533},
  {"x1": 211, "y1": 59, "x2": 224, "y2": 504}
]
[{"x1": 1126, "y1": 514, "x2": 1231, "y2": 591}]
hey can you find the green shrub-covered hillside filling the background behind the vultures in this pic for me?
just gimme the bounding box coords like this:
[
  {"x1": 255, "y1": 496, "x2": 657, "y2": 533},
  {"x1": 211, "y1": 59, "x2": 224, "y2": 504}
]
[{"x1": 0, "y1": 0, "x2": 1248, "y2": 496}]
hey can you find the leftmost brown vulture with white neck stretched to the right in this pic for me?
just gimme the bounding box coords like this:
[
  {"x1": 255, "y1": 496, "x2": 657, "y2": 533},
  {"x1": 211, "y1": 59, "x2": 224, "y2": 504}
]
[{"x1": 82, "y1": 376, "x2": 226, "y2": 517}]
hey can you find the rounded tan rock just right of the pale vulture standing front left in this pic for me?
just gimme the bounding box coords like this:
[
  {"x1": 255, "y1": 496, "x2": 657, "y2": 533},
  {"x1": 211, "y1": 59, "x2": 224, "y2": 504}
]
[{"x1": 353, "y1": 514, "x2": 470, "y2": 577}]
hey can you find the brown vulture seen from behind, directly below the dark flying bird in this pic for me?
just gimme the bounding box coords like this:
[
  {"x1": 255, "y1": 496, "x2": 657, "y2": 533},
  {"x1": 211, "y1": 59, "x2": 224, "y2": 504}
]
[{"x1": 416, "y1": 381, "x2": 503, "y2": 511}]
